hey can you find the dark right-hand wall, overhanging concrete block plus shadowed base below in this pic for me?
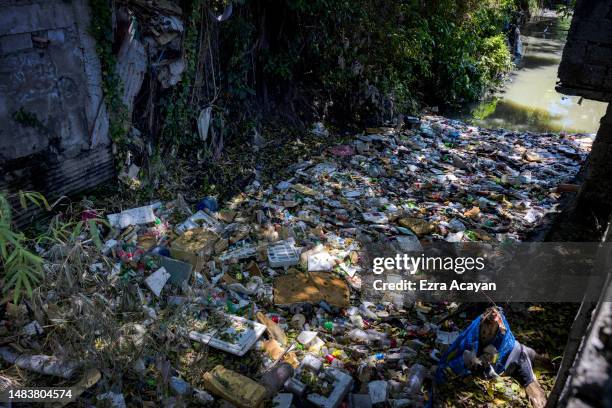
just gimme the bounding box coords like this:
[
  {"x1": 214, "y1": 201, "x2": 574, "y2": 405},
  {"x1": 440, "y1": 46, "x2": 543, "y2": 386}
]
[{"x1": 557, "y1": 0, "x2": 612, "y2": 241}]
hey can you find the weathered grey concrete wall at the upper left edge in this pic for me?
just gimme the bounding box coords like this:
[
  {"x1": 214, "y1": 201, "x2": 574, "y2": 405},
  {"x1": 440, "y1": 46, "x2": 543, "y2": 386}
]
[{"x1": 0, "y1": 0, "x2": 114, "y2": 222}]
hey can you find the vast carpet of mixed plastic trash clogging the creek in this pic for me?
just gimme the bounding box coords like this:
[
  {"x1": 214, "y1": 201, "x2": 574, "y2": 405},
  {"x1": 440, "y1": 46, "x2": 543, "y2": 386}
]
[{"x1": 0, "y1": 117, "x2": 590, "y2": 408}]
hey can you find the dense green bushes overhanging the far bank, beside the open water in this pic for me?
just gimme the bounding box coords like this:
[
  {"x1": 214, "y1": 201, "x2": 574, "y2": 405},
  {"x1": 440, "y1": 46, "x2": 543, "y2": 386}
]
[{"x1": 220, "y1": 0, "x2": 520, "y2": 121}]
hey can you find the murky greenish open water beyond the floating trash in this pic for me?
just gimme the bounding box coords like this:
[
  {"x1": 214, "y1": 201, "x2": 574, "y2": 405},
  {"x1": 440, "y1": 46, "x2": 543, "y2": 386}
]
[{"x1": 449, "y1": 12, "x2": 606, "y2": 133}]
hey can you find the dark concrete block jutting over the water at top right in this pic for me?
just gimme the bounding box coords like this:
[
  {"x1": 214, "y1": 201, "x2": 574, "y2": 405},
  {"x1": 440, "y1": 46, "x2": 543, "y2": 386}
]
[{"x1": 558, "y1": 0, "x2": 612, "y2": 102}]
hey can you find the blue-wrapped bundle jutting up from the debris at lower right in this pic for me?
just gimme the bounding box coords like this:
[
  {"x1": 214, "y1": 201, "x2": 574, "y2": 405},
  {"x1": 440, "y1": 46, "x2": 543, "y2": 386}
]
[{"x1": 435, "y1": 306, "x2": 546, "y2": 408}]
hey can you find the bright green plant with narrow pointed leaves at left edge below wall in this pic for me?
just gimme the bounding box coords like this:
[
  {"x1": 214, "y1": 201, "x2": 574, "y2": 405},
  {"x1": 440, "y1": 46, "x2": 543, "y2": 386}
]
[{"x1": 0, "y1": 191, "x2": 50, "y2": 303}]
